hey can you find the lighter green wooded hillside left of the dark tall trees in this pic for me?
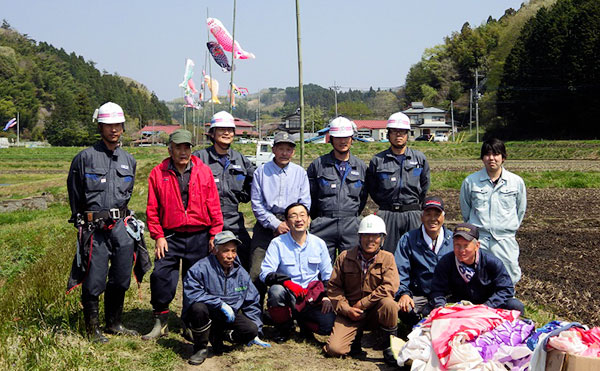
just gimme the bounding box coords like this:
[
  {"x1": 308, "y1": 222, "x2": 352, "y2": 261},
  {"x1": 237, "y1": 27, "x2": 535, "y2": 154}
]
[{"x1": 405, "y1": 0, "x2": 557, "y2": 136}]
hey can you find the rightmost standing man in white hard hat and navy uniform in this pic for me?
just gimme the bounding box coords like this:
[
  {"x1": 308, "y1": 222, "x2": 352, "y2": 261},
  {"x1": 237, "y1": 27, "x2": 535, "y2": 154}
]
[{"x1": 366, "y1": 112, "x2": 430, "y2": 253}]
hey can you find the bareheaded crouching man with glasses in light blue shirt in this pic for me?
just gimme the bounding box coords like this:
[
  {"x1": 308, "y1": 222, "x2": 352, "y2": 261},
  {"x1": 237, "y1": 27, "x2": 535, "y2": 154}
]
[{"x1": 259, "y1": 203, "x2": 335, "y2": 343}]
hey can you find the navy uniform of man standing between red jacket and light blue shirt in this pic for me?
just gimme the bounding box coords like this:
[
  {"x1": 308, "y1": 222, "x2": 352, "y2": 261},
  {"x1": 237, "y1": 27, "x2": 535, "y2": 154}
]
[{"x1": 193, "y1": 145, "x2": 254, "y2": 271}]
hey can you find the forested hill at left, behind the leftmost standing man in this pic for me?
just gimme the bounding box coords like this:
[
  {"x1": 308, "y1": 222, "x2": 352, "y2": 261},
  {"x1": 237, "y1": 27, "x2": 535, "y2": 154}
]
[{"x1": 0, "y1": 21, "x2": 171, "y2": 145}]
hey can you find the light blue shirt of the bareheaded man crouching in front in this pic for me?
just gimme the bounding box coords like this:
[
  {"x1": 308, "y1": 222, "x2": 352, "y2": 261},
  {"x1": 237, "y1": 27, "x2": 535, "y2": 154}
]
[{"x1": 259, "y1": 232, "x2": 333, "y2": 288}]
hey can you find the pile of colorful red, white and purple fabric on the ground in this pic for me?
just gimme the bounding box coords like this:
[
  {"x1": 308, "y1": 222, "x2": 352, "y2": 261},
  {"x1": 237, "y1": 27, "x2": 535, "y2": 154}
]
[{"x1": 398, "y1": 305, "x2": 600, "y2": 371}]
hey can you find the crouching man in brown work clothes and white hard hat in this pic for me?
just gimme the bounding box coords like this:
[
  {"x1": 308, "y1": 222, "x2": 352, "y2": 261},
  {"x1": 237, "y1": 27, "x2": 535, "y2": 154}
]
[{"x1": 324, "y1": 215, "x2": 399, "y2": 364}]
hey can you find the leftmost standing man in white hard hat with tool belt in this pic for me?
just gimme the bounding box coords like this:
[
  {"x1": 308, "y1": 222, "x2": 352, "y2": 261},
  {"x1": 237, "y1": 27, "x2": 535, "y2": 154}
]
[{"x1": 67, "y1": 102, "x2": 137, "y2": 343}]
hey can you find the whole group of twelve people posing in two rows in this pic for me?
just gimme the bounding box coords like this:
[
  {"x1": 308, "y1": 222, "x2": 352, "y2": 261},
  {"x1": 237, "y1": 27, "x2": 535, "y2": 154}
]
[{"x1": 67, "y1": 102, "x2": 526, "y2": 365}]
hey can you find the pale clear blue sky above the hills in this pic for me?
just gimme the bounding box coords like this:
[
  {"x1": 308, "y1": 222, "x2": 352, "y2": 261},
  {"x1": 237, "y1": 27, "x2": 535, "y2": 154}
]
[{"x1": 0, "y1": 0, "x2": 523, "y2": 101}]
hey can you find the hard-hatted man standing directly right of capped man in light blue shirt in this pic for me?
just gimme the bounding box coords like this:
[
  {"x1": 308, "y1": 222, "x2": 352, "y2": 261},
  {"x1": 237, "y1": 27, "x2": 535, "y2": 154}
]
[{"x1": 307, "y1": 117, "x2": 367, "y2": 262}]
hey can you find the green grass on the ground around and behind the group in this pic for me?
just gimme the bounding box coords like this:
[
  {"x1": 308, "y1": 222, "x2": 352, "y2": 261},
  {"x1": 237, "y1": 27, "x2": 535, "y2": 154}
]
[{"x1": 0, "y1": 141, "x2": 600, "y2": 370}]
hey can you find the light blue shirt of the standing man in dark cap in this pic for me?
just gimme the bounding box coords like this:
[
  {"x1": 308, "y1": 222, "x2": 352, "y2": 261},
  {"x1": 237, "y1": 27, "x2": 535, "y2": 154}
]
[{"x1": 251, "y1": 161, "x2": 310, "y2": 230}]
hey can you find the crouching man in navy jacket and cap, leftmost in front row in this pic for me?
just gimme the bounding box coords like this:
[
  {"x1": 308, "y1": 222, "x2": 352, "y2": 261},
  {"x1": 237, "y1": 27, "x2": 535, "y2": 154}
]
[{"x1": 182, "y1": 231, "x2": 270, "y2": 365}]
